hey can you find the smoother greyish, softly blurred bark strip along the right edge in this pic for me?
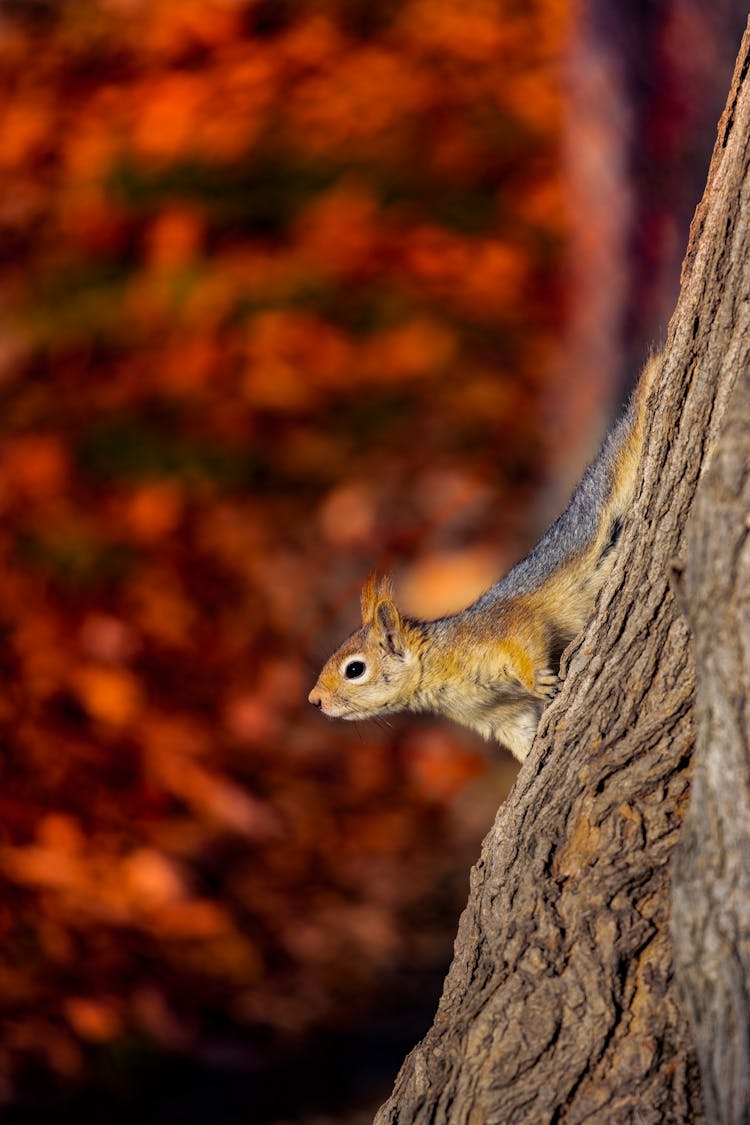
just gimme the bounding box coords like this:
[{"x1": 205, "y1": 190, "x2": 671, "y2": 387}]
[{"x1": 672, "y1": 43, "x2": 750, "y2": 1111}]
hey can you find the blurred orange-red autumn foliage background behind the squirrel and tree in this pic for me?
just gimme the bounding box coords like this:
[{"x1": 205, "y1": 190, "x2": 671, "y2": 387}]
[{"x1": 0, "y1": 0, "x2": 746, "y2": 1125}]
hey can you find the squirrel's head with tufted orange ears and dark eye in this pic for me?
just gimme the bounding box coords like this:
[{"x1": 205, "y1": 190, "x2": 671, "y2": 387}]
[{"x1": 308, "y1": 575, "x2": 419, "y2": 719}]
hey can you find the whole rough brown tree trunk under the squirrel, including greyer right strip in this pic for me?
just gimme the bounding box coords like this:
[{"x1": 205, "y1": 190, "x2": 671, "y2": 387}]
[{"x1": 376, "y1": 17, "x2": 750, "y2": 1125}]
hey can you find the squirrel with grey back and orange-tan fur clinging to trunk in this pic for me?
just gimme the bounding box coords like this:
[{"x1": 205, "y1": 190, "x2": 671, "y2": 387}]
[{"x1": 308, "y1": 354, "x2": 661, "y2": 762}]
